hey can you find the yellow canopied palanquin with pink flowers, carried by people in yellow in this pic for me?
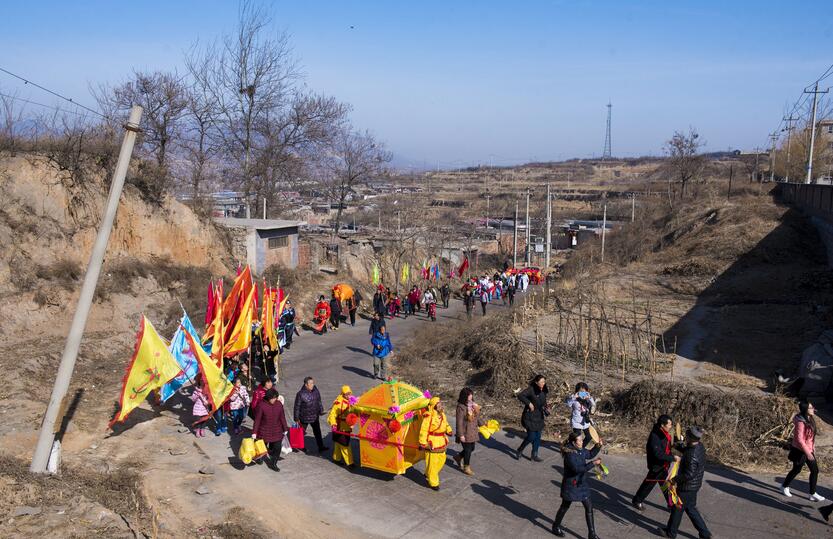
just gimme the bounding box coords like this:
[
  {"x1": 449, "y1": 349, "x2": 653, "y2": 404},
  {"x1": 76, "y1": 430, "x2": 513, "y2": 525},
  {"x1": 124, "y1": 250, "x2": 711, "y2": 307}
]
[{"x1": 351, "y1": 380, "x2": 428, "y2": 474}]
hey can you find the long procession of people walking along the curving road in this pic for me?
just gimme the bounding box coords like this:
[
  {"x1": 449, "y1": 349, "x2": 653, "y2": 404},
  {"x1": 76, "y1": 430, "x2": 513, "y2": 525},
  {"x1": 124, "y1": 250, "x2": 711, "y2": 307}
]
[{"x1": 182, "y1": 272, "x2": 833, "y2": 539}]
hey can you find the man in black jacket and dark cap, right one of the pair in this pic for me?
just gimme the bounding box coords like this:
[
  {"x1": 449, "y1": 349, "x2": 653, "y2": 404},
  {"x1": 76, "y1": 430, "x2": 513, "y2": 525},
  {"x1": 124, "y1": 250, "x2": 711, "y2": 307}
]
[{"x1": 660, "y1": 427, "x2": 712, "y2": 539}]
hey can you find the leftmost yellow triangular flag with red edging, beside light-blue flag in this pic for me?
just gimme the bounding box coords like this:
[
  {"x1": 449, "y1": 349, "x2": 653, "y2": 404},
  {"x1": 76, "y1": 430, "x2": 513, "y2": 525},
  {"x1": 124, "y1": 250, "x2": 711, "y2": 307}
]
[{"x1": 109, "y1": 315, "x2": 182, "y2": 428}]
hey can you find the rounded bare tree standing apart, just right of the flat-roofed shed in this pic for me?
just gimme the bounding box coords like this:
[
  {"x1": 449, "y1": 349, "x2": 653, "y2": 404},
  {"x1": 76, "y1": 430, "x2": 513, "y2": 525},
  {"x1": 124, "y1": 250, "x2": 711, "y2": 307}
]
[{"x1": 324, "y1": 130, "x2": 391, "y2": 233}]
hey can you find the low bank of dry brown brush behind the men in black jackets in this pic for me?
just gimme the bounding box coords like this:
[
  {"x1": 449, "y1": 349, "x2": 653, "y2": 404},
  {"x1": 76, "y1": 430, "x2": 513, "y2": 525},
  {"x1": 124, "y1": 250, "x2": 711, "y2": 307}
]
[{"x1": 613, "y1": 380, "x2": 796, "y2": 465}]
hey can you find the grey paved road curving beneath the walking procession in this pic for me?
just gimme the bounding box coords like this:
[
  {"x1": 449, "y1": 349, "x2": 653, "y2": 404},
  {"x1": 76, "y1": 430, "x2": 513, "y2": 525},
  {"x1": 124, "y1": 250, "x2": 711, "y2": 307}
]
[{"x1": 190, "y1": 296, "x2": 833, "y2": 538}]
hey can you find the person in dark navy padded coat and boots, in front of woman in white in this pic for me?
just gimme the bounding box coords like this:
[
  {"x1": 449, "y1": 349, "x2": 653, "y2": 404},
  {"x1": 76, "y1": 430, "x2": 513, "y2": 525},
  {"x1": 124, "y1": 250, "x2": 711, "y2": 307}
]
[{"x1": 552, "y1": 432, "x2": 602, "y2": 539}]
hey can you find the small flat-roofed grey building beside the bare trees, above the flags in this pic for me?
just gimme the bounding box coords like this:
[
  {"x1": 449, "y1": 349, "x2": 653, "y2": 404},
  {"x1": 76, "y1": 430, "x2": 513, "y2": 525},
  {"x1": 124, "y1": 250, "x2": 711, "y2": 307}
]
[{"x1": 215, "y1": 217, "x2": 306, "y2": 275}]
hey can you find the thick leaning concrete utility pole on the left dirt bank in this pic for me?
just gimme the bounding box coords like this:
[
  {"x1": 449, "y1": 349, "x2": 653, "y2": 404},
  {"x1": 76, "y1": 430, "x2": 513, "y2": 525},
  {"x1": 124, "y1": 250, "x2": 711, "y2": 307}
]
[{"x1": 29, "y1": 105, "x2": 142, "y2": 473}]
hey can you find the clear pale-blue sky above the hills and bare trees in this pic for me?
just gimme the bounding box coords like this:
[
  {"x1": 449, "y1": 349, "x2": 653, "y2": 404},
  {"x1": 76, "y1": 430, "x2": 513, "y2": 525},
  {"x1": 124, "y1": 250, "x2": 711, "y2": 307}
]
[{"x1": 0, "y1": 0, "x2": 833, "y2": 168}]
